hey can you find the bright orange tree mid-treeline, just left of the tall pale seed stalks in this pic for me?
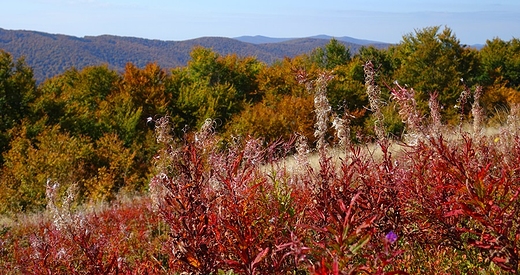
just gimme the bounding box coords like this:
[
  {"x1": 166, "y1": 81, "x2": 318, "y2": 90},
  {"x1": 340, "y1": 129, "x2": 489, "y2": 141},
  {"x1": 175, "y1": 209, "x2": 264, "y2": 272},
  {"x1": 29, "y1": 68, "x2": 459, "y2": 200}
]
[{"x1": 225, "y1": 56, "x2": 316, "y2": 142}]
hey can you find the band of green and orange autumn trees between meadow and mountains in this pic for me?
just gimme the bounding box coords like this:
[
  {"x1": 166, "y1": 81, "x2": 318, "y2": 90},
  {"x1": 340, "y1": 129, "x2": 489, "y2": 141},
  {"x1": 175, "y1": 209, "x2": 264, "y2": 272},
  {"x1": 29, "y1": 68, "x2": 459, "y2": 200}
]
[{"x1": 0, "y1": 27, "x2": 520, "y2": 214}]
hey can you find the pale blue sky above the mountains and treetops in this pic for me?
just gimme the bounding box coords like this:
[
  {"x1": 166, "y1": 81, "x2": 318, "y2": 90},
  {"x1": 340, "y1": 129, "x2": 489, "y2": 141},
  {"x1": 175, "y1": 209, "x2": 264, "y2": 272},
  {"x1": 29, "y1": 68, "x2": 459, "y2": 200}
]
[{"x1": 0, "y1": 0, "x2": 520, "y2": 45}]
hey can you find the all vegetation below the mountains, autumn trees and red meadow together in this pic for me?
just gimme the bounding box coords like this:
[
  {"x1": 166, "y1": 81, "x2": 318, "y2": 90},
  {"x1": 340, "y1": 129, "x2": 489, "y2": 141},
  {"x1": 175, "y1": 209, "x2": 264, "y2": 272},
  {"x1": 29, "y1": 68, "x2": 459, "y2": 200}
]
[{"x1": 0, "y1": 24, "x2": 520, "y2": 274}]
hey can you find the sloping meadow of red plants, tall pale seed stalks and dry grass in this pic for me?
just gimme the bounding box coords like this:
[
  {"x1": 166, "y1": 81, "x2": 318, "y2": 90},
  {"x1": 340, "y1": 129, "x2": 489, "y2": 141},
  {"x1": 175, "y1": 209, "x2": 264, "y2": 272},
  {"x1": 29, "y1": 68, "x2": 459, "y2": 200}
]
[{"x1": 0, "y1": 62, "x2": 520, "y2": 274}]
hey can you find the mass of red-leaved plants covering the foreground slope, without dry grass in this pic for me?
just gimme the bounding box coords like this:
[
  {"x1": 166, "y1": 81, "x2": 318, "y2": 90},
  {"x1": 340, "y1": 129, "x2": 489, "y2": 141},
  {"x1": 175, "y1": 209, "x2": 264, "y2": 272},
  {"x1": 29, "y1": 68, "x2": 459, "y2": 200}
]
[{"x1": 6, "y1": 116, "x2": 520, "y2": 275}]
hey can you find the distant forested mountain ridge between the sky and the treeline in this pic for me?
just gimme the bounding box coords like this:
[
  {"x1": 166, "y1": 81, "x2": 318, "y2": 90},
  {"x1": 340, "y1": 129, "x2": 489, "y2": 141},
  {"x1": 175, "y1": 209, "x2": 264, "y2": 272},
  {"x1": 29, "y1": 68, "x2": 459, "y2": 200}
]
[{"x1": 0, "y1": 28, "x2": 390, "y2": 82}]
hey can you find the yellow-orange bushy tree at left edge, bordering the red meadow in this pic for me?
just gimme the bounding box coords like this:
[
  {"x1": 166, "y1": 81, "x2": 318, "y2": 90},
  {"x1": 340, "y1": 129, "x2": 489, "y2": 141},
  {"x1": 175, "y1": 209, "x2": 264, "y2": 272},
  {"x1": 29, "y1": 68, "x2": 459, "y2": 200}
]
[{"x1": 0, "y1": 125, "x2": 93, "y2": 213}]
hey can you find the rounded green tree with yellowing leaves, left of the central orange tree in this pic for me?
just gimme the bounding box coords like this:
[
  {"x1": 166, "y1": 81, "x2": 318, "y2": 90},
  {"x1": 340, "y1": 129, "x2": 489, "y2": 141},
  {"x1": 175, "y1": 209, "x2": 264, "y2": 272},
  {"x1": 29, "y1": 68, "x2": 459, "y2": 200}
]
[{"x1": 171, "y1": 47, "x2": 263, "y2": 132}]
